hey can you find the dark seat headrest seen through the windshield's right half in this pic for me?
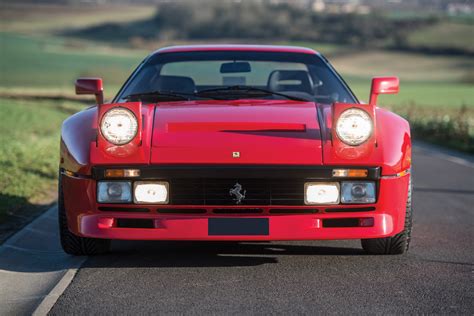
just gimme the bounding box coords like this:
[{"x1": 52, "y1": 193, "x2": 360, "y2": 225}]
[{"x1": 268, "y1": 70, "x2": 313, "y2": 94}]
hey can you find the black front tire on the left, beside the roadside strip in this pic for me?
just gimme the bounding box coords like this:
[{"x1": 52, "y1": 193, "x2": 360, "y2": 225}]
[{"x1": 58, "y1": 174, "x2": 110, "y2": 256}]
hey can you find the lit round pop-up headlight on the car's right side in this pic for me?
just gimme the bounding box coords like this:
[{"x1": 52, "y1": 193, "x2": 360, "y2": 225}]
[{"x1": 336, "y1": 108, "x2": 373, "y2": 146}]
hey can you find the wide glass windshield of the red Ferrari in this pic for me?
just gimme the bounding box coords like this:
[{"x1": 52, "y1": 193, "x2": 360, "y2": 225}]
[{"x1": 117, "y1": 51, "x2": 357, "y2": 103}]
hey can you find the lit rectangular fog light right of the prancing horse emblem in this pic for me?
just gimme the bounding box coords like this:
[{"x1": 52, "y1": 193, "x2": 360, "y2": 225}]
[{"x1": 304, "y1": 182, "x2": 339, "y2": 205}]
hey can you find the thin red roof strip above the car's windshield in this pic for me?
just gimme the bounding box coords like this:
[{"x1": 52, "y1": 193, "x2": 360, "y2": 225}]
[{"x1": 152, "y1": 44, "x2": 318, "y2": 55}]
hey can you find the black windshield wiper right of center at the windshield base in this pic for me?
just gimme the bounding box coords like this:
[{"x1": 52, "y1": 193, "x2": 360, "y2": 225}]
[{"x1": 195, "y1": 85, "x2": 309, "y2": 102}]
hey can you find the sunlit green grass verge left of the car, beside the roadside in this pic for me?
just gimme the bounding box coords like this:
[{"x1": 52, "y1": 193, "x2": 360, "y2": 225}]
[{"x1": 0, "y1": 98, "x2": 84, "y2": 224}]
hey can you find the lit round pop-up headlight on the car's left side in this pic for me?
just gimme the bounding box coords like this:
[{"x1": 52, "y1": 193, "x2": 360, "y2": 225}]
[{"x1": 100, "y1": 107, "x2": 138, "y2": 145}]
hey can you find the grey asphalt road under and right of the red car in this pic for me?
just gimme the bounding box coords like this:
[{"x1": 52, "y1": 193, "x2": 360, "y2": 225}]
[{"x1": 51, "y1": 147, "x2": 474, "y2": 315}]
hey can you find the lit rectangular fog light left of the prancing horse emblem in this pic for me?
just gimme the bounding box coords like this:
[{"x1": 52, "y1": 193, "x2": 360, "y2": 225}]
[{"x1": 134, "y1": 181, "x2": 169, "y2": 204}]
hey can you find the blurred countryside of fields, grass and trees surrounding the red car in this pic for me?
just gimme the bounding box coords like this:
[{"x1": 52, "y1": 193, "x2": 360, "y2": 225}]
[{"x1": 0, "y1": 0, "x2": 474, "y2": 238}]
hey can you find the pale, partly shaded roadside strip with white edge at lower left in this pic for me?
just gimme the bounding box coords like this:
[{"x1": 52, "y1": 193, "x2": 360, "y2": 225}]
[{"x1": 0, "y1": 207, "x2": 86, "y2": 315}]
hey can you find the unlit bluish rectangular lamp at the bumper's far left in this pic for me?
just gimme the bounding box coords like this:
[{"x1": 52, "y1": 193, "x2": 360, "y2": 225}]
[{"x1": 97, "y1": 181, "x2": 132, "y2": 203}]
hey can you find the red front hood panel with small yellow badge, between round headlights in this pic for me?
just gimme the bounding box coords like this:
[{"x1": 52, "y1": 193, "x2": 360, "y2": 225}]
[{"x1": 151, "y1": 100, "x2": 322, "y2": 165}]
